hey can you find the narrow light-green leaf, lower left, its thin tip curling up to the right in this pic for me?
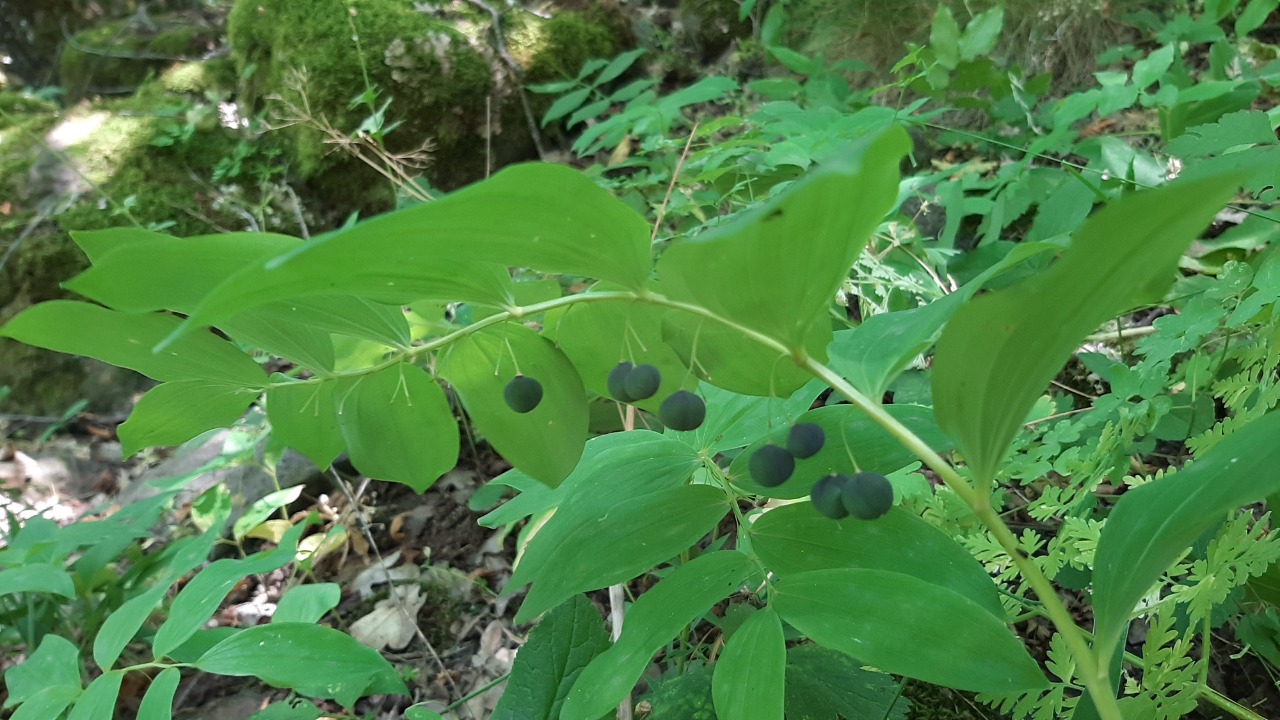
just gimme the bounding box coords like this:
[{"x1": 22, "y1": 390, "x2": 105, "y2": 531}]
[{"x1": 151, "y1": 515, "x2": 307, "y2": 660}]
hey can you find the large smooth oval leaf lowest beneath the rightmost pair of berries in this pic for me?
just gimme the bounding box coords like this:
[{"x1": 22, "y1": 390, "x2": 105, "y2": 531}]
[{"x1": 771, "y1": 569, "x2": 1048, "y2": 693}]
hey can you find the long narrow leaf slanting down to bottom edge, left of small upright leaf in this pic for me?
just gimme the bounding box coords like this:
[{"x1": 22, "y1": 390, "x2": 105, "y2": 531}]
[{"x1": 561, "y1": 550, "x2": 756, "y2": 720}]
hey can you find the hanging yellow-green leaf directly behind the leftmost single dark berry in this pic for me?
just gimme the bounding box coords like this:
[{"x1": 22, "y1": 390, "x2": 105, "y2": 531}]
[{"x1": 440, "y1": 323, "x2": 588, "y2": 486}]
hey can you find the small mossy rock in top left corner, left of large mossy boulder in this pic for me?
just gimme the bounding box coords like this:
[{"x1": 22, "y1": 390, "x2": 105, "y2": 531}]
[{"x1": 58, "y1": 14, "x2": 220, "y2": 100}]
